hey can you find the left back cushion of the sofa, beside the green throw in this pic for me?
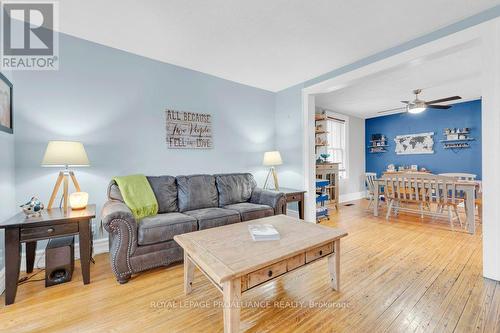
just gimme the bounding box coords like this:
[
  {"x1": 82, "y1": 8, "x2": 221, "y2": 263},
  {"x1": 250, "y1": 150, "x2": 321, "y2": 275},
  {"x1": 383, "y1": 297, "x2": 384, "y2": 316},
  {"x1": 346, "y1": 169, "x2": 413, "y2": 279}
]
[{"x1": 147, "y1": 176, "x2": 178, "y2": 214}]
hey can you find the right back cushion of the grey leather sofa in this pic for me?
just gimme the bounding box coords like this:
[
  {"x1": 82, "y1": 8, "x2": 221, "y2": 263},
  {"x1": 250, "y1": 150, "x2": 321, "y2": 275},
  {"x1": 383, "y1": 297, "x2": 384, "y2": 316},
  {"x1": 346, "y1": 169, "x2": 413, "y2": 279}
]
[{"x1": 215, "y1": 173, "x2": 257, "y2": 207}]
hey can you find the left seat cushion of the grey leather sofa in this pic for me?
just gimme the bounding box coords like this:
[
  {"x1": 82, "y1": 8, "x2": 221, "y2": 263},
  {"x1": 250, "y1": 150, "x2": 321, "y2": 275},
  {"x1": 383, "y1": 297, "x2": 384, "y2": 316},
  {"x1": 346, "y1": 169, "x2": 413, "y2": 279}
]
[{"x1": 137, "y1": 213, "x2": 198, "y2": 245}]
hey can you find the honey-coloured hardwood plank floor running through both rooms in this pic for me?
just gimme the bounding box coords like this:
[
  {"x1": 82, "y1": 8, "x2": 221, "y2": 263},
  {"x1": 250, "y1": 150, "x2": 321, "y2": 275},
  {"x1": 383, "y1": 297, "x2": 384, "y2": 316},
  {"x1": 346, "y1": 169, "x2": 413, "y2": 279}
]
[{"x1": 0, "y1": 200, "x2": 500, "y2": 332}]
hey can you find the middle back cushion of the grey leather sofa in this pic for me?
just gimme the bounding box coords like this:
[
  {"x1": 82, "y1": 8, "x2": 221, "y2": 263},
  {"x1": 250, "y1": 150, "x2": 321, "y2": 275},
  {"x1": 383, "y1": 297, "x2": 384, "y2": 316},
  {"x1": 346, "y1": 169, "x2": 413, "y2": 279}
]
[{"x1": 177, "y1": 175, "x2": 218, "y2": 212}]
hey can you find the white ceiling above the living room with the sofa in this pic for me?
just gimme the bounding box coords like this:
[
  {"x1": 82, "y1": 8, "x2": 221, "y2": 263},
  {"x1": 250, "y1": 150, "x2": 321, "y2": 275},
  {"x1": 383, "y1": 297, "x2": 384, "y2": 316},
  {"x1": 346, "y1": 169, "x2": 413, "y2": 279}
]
[{"x1": 59, "y1": 0, "x2": 500, "y2": 91}]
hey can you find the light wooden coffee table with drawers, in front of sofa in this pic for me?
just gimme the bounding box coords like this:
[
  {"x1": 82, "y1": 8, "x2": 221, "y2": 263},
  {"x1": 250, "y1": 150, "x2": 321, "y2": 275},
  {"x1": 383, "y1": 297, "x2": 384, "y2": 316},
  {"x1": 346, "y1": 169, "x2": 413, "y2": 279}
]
[{"x1": 174, "y1": 215, "x2": 347, "y2": 332}]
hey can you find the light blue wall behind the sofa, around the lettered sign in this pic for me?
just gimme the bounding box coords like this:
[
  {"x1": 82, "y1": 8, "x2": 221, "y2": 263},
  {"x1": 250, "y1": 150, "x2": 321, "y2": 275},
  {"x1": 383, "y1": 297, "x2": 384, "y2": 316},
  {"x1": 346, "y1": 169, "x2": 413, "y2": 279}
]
[{"x1": 13, "y1": 35, "x2": 275, "y2": 243}]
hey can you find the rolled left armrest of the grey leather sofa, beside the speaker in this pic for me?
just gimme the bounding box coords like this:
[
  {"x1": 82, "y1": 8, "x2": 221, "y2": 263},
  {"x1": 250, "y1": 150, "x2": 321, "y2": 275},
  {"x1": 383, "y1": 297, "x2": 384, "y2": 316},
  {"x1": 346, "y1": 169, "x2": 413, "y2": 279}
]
[{"x1": 101, "y1": 200, "x2": 137, "y2": 283}]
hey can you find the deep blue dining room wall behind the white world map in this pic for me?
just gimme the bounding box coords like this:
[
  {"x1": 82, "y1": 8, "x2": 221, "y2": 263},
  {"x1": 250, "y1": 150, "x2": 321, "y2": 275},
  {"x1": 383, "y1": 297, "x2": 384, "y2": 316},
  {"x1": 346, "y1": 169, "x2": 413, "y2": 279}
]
[{"x1": 365, "y1": 100, "x2": 481, "y2": 179}]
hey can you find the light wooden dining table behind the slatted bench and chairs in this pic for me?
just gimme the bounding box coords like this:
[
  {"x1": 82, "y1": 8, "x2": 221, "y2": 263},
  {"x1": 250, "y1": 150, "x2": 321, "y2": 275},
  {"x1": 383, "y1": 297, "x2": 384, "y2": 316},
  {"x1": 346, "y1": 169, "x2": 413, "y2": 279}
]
[{"x1": 373, "y1": 175, "x2": 481, "y2": 234}]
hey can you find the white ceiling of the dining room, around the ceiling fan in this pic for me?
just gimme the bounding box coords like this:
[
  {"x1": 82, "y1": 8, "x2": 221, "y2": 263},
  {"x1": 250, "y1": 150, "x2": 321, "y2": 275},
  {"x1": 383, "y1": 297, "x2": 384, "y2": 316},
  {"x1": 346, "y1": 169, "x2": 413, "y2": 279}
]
[{"x1": 315, "y1": 44, "x2": 481, "y2": 118}]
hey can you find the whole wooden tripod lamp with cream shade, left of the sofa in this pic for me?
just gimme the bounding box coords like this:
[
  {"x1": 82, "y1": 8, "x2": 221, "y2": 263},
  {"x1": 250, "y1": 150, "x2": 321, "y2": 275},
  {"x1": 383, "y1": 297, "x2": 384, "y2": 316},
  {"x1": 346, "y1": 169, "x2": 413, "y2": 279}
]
[{"x1": 42, "y1": 141, "x2": 90, "y2": 211}]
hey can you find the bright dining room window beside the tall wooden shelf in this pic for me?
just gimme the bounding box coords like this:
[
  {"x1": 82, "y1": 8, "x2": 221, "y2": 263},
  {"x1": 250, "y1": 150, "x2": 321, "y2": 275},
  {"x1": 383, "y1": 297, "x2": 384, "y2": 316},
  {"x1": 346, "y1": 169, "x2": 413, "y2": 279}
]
[{"x1": 326, "y1": 113, "x2": 348, "y2": 179}]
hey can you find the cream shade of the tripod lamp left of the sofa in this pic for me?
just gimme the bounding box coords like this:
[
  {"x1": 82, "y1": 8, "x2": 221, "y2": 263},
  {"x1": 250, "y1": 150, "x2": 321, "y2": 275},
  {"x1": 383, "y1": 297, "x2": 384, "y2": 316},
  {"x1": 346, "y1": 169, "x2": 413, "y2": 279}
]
[{"x1": 42, "y1": 141, "x2": 90, "y2": 167}]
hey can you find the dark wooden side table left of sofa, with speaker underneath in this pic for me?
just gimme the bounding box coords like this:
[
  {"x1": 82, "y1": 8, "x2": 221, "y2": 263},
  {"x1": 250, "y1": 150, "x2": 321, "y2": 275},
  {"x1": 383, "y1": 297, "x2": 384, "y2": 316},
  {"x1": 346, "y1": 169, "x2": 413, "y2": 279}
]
[{"x1": 0, "y1": 205, "x2": 95, "y2": 305}]
